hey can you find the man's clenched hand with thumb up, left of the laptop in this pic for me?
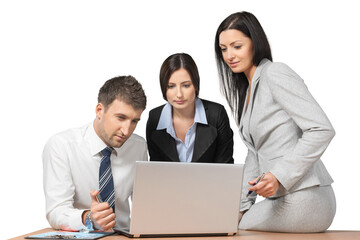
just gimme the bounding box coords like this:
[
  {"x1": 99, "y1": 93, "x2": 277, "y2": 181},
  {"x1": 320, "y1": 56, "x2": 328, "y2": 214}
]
[{"x1": 90, "y1": 190, "x2": 115, "y2": 231}]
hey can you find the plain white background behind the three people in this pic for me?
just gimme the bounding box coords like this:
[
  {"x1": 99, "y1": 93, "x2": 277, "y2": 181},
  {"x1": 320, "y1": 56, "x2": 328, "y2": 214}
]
[{"x1": 0, "y1": 0, "x2": 360, "y2": 239}]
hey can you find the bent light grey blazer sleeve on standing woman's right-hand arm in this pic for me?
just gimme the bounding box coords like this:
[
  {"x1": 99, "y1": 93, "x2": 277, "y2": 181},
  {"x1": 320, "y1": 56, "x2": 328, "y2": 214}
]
[{"x1": 265, "y1": 63, "x2": 335, "y2": 190}]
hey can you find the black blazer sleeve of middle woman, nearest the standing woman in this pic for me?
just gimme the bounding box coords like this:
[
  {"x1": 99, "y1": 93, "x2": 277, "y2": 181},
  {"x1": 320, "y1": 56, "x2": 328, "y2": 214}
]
[{"x1": 214, "y1": 106, "x2": 234, "y2": 163}]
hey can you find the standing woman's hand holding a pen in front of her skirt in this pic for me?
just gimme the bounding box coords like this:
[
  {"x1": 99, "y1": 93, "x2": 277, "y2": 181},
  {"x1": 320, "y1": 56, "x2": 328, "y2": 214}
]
[{"x1": 249, "y1": 172, "x2": 280, "y2": 198}]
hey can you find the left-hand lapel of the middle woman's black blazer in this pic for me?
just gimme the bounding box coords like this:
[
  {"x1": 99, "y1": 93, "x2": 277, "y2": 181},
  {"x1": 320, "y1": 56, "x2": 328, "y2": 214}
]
[{"x1": 151, "y1": 129, "x2": 180, "y2": 162}]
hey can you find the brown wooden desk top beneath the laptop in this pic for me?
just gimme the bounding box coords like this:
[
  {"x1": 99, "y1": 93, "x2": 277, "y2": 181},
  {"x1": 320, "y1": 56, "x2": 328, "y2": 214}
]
[{"x1": 10, "y1": 228, "x2": 360, "y2": 240}]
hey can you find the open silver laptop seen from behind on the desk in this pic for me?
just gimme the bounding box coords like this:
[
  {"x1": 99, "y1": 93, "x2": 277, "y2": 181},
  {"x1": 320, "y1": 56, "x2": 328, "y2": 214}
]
[{"x1": 116, "y1": 162, "x2": 244, "y2": 237}]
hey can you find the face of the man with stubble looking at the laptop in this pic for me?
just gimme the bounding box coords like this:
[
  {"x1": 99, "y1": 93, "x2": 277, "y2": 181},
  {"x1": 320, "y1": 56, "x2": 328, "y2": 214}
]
[{"x1": 94, "y1": 99, "x2": 143, "y2": 148}]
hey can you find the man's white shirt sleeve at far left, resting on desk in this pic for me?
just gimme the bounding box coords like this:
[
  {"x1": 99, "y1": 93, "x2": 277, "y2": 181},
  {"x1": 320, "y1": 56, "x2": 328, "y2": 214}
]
[{"x1": 42, "y1": 137, "x2": 85, "y2": 230}]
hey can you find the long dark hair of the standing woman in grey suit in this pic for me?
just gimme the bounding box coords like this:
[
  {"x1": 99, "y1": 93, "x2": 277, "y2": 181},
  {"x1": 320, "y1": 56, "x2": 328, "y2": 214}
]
[{"x1": 215, "y1": 12, "x2": 272, "y2": 125}]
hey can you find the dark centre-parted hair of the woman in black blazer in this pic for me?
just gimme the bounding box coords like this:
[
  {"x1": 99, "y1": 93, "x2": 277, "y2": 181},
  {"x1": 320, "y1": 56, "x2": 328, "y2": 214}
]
[{"x1": 160, "y1": 53, "x2": 200, "y2": 101}]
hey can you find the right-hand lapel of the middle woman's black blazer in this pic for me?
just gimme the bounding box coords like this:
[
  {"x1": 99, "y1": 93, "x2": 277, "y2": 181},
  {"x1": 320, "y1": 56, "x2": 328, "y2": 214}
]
[{"x1": 191, "y1": 123, "x2": 217, "y2": 162}]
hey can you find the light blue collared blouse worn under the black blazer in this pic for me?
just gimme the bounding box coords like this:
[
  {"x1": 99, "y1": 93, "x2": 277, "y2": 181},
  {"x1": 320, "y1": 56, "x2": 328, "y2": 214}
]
[{"x1": 156, "y1": 98, "x2": 208, "y2": 162}]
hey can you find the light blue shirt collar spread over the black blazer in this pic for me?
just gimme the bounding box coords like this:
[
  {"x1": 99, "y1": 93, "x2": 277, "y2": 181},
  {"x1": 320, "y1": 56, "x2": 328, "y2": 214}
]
[{"x1": 156, "y1": 98, "x2": 208, "y2": 130}]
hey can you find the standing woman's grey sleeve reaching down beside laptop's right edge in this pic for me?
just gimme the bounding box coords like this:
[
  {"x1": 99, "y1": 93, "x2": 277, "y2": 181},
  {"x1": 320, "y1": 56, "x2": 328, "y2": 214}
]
[{"x1": 240, "y1": 150, "x2": 260, "y2": 212}]
